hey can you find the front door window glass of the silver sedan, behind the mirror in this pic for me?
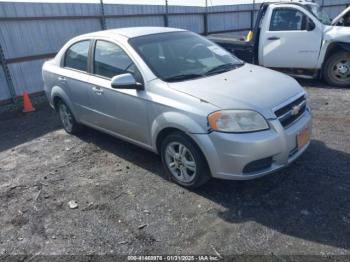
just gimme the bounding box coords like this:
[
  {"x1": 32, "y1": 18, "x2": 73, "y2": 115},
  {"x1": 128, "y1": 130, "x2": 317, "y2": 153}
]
[{"x1": 94, "y1": 40, "x2": 137, "y2": 78}]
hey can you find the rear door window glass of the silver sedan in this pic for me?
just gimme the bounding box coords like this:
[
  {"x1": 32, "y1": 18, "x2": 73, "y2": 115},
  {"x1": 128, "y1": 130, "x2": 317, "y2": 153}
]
[{"x1": 64, "y1": 40, "x2": 90, "y2": 72}]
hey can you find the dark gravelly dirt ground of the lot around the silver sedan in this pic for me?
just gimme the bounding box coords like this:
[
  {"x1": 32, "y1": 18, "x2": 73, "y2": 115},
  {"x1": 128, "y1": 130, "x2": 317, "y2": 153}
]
[{"x1": 0, "y1": 82, "x2": 350, "y2": 257}]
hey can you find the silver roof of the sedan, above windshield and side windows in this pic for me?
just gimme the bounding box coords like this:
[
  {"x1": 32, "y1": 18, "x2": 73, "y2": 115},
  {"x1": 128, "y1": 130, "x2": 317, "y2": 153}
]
[{"x1": 79, "y1": 26, "x2": 186, "y2": 38}]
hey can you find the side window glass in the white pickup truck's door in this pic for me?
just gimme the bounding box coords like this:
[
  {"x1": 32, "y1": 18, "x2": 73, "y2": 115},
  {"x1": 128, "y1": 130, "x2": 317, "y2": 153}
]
[{"x1": 270, "y1": 8, "x2": 307, "y2": 31}]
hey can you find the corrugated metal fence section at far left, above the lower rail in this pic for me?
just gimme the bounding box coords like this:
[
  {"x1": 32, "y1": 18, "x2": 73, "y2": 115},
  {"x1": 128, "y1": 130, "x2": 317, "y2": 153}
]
[{"x1": 0, "y1": 2, "x2": 100, "y2": 59}]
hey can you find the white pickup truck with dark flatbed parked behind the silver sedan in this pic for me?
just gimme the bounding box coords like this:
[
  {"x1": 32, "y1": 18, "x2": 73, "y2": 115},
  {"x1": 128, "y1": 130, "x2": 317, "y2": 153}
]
[{"x1": 208, "y1": 1, "x2": 350, "y2": 87}]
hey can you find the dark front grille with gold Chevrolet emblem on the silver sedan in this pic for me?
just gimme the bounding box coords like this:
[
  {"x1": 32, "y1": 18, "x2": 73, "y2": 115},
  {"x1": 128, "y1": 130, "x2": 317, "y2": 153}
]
[{"x1": 275, "y1": 96, "x2": 306, "y2": 128}]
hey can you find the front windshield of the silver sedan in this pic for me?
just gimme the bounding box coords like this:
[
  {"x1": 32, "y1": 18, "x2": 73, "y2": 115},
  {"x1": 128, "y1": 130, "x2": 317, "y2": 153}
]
[{"x1": 129, "y1": 31, "x2": 243, "y2": 82}]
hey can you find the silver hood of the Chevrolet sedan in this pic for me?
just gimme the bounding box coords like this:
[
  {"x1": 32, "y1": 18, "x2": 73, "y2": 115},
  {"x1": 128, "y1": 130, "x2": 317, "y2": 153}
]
[{"x1": 169, "y1": 64, "x2": 305, "y2": 118}]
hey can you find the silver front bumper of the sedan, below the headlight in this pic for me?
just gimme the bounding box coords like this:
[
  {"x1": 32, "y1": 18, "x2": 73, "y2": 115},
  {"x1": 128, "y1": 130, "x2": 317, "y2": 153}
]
[{"x1": 193, "y1": 110, "x2": 312, "y2": 180}]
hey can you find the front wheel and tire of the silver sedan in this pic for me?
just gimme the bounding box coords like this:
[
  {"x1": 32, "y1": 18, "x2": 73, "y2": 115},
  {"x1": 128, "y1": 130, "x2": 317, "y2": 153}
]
[{"x1": 160, "y1": 132, "x2": 211, "y2": 189}]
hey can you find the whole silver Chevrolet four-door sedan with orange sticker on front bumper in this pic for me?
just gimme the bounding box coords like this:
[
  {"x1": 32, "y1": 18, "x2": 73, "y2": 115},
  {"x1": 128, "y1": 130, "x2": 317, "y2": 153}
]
[{"x1": 43, "y1": 27, "x2": 311, "y2": 188}]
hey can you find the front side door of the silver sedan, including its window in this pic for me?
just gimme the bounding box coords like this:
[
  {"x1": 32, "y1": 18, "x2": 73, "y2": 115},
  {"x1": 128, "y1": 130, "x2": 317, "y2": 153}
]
[{"x1": 89, "y1": 40, "x2": 150, "y2": 144}]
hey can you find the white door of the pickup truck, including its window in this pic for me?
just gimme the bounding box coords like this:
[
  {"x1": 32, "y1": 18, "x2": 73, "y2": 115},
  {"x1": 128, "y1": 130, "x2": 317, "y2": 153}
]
[{"x1": 259, "y1": 5, "x2": 323, "y2": 69}]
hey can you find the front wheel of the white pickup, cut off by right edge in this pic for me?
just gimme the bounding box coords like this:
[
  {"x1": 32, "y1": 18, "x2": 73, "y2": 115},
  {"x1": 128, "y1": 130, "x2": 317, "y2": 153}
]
[{"x1": 323, "y1": 51, "x2": 350, "y2": 88}]
